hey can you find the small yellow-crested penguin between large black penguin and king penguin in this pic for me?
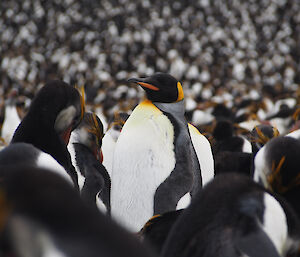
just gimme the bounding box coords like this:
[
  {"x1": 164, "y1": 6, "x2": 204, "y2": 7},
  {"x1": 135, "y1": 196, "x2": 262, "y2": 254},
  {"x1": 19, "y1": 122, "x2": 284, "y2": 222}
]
[{"x1": 68, "y1": 112, "x2": 111, "y2": 214}]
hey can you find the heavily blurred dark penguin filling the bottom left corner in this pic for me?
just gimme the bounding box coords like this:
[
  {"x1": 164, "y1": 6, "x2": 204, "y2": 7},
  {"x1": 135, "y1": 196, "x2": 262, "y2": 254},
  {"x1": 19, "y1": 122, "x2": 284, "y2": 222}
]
[{"x1": 0, "y1": 165, "x2": 153, "y2": 257}]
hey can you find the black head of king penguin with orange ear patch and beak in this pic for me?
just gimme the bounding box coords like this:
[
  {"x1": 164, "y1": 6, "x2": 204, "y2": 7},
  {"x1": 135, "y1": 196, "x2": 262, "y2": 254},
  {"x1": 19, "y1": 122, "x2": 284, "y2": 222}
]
[{"x1": 128, "y1": 73, "x2": 184, "y2": 103}]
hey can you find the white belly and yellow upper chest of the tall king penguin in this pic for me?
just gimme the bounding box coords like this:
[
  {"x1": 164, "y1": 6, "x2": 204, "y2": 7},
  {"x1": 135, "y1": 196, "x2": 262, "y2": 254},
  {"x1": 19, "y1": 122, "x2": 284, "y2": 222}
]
[{"x1": 111, "y1": 101, "x2": 175, "y2": 232}]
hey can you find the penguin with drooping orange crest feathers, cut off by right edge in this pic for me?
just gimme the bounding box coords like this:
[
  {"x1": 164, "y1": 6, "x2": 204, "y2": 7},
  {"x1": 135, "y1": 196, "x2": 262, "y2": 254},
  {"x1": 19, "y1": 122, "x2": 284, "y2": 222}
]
[{"x1": 254, "y1": 131, "x2": 300, "y2": 218}]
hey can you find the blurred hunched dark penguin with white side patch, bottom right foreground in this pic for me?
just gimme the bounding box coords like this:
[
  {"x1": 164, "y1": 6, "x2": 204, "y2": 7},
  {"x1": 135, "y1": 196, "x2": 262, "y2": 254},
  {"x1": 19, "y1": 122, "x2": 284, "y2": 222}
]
[{"x1": 161, "y1": 173, "x2": 299, "y2": 257}]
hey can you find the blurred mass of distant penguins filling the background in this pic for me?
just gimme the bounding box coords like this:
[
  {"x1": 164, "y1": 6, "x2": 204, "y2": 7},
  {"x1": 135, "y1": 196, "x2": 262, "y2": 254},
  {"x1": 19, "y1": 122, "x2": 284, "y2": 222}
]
[{"x1": 0, "y1": 0, "x2": 300, "y2": 124}]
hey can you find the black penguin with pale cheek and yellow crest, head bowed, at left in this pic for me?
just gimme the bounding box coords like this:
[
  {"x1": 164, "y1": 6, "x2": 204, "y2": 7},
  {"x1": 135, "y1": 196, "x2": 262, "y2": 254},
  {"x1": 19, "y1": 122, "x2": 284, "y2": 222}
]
[{"x1": 11, "y1": 80, "x2": 84, "y2": 186}]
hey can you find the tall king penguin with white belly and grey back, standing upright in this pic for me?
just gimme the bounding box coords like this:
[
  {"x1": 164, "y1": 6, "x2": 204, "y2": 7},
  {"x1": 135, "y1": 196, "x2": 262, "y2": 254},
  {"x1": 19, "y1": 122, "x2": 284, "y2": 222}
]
[{"x1": 111, "y1": 73, "x2": 202, "y2": 232}]
